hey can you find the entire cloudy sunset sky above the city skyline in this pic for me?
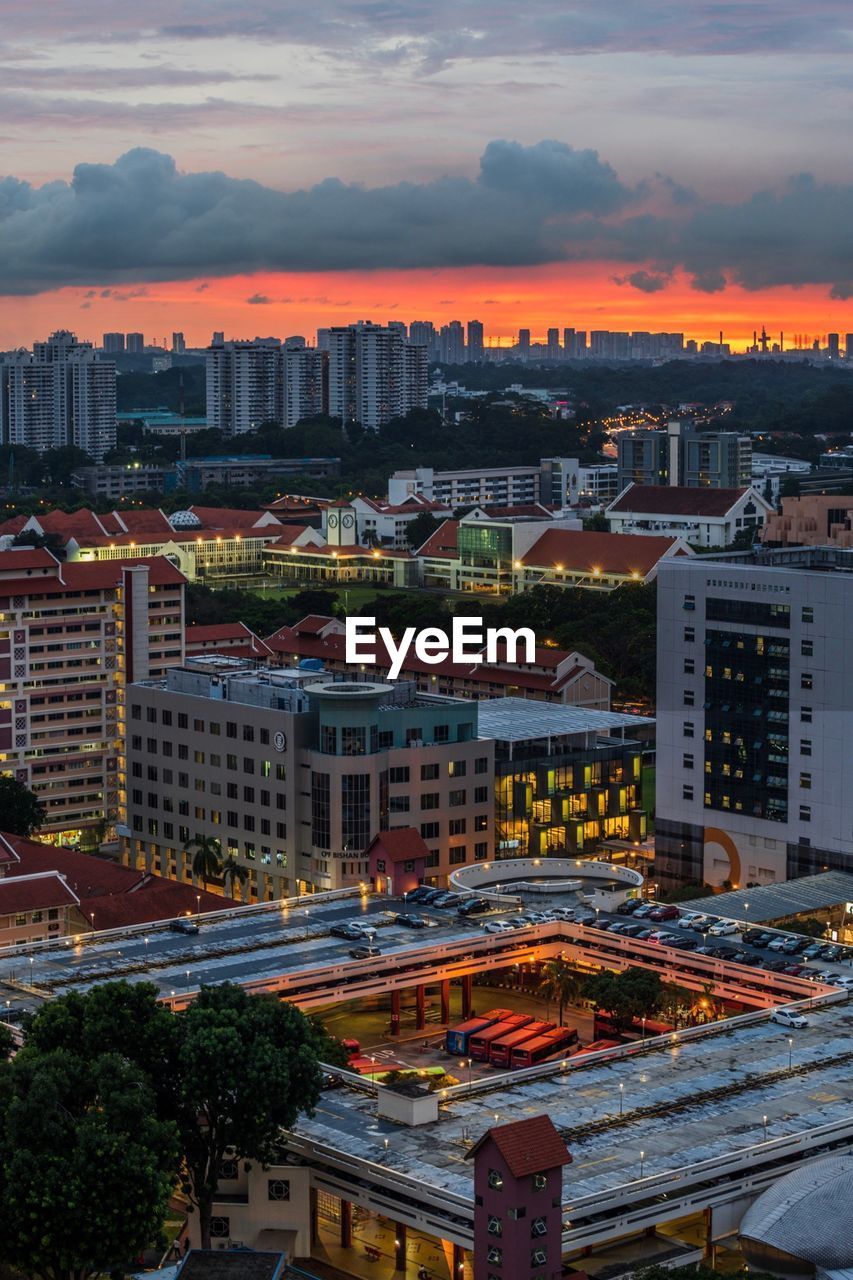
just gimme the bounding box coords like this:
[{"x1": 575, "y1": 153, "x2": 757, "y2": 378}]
[{"x1": 0, "y1": 0, "x2": 853, "y2": 347}]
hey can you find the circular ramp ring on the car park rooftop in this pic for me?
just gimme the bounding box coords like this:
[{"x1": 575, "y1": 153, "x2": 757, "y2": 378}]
[{"x1": 450, "y1": 858, "x2": 643, "y2": 909}]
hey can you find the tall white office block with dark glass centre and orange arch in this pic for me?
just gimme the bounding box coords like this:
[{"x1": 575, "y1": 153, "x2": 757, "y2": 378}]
[{"x1": 656, "y1": 548, "x2": 853, "y2": 887}]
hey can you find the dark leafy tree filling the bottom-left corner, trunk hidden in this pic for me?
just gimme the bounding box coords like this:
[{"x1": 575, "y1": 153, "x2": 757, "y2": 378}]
[{"x1": 0, "y1": 1048, "x2": 178, "y2": 1280}]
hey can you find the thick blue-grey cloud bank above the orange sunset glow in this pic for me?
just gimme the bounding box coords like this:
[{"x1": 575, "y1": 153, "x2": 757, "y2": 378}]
[{"x1": 0, "y1": 141, "x2": 853, "y2": 296}]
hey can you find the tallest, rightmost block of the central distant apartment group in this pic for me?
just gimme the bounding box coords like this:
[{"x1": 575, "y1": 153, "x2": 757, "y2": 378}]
[{"x1": 329, "y1": 320, "x2": 429, "y2": 431}]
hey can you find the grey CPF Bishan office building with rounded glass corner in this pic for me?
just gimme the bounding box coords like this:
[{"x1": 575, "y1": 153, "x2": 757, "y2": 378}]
[{"x1": 124, "y1": 658, "x2": 493, "y2": 901}]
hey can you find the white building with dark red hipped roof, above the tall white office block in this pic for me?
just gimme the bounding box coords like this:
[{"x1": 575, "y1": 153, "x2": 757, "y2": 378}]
[{"x1": 605, "y1": 484, "x2": 774, "y2": 548}]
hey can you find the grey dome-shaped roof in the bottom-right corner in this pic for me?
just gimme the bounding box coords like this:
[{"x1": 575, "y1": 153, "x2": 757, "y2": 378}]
[{"x1": 739, "y1": 1156, "x2": 853, "y2": 1270}]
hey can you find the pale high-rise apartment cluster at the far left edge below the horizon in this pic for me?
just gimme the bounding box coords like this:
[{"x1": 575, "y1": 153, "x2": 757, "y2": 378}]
[{"x1": 0, "y1": 329, "x2": 115, "y2": 462}]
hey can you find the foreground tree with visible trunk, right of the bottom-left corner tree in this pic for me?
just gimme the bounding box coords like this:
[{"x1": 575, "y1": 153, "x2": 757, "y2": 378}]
[{"x1": 178, "y1": 984, "x2": 323, "y2": 1248}]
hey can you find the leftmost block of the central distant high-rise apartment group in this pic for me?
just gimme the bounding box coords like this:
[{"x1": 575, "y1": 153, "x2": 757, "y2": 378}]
[{"x1": 205, "y1": 338, "x2": 284, "y2": 435}]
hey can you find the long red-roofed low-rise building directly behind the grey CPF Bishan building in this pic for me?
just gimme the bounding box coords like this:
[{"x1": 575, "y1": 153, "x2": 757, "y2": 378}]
[{"x1": 265, "y1": 616, "x2": 613, "y2": 710}]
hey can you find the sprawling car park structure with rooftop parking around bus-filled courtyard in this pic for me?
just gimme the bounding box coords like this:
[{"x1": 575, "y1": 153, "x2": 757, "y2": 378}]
[{"x1": 0, "y1": 859, "x2": 853, "y2": 1280}]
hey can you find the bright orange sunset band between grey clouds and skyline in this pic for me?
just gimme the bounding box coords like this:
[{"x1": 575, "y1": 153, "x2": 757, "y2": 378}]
[{"x1": 8, "y1": 264, "x2": 853, "y2": 349}]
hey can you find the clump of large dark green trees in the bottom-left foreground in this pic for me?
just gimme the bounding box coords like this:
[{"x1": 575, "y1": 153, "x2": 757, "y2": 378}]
[{"x1": 0, "y1": 982, "x2": 346, "y2": 1280}]
